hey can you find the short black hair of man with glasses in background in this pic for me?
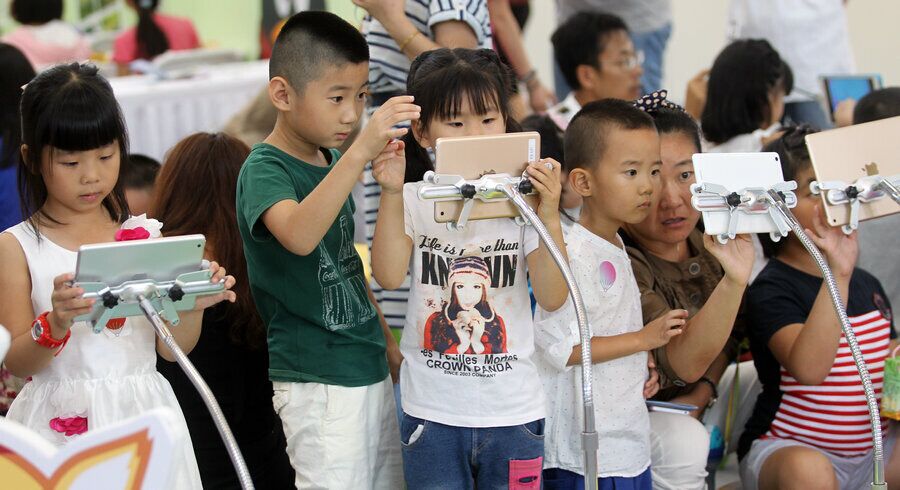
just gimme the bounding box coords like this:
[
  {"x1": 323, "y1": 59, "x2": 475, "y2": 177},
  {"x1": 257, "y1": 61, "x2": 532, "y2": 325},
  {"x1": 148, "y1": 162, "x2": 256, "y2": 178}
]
[{"x1": 550, "y1": 12, "x2": 628, "y2": 90}]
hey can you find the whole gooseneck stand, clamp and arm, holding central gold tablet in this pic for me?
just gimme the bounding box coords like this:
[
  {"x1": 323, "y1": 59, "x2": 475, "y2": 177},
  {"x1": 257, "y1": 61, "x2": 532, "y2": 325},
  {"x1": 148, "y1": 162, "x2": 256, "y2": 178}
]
[{"x1": 419, "y1": 171, "x2": 598, "y2": 490}]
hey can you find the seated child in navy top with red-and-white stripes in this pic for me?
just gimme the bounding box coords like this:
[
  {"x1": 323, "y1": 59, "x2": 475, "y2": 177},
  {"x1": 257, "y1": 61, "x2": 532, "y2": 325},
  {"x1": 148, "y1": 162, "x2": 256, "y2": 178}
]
[{"x1": 738, "y1": 127, "x2": 900, "y2": 490}]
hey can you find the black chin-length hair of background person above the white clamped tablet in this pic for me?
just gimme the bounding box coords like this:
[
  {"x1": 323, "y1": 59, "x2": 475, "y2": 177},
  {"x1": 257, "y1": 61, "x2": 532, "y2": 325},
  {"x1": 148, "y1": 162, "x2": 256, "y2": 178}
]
[{"x1": 700, "y1": 39, "x2": 794, "y2": 143}]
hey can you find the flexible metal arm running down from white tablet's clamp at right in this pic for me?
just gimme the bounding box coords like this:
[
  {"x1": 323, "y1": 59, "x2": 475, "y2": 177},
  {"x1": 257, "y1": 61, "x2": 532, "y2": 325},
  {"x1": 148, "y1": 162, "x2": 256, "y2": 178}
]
[{"x1": 769, "y1": 190, "x2": 887, "y2": 490}]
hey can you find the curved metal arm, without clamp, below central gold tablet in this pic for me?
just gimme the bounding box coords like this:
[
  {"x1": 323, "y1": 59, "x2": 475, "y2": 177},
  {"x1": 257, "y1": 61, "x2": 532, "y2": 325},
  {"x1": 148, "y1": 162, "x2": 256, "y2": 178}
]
[{"x1": 501, "y1": 184, "x2": 599, "y2": 490}]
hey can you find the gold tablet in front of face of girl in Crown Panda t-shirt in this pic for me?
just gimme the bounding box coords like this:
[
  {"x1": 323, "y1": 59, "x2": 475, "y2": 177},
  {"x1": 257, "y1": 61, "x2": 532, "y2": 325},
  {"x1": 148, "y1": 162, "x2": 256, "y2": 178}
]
[{"x1": 434, "y1": 131, "x2": 541, "y2": 223}]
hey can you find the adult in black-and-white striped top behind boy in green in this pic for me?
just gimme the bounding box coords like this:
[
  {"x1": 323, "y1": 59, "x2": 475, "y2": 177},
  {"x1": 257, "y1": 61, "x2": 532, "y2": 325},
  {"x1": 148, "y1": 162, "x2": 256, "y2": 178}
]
[{"x1": 353, "y1": 0, "x2": 493, "y2": 328}]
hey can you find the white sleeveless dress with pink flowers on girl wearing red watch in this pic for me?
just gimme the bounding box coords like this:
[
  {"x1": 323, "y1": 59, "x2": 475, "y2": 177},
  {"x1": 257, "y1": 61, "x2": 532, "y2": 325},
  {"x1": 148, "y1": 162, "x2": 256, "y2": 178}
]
[{"x1": 7, "y1": 222, "x2": 202, "y2": 489}]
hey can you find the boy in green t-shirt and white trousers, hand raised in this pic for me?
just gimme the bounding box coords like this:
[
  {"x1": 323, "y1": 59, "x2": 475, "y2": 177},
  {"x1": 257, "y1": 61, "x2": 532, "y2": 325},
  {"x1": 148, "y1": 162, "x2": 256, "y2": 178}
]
[{"x1": 230, "y1": 12, "x2": 419, "y2": 488}]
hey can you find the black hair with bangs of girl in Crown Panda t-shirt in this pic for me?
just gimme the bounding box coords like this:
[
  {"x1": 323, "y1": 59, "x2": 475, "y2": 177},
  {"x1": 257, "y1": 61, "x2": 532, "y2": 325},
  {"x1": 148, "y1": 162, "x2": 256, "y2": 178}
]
[{"x1": 403, "y1": 48, "x2": 520, "y2": 182}]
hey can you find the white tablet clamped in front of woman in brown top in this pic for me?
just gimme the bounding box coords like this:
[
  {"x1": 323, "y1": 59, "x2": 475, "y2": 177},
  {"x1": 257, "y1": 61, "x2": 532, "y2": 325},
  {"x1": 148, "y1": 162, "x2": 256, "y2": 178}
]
[{"x1": 692, "y1": 152, "x2": 784, "y2": 236}]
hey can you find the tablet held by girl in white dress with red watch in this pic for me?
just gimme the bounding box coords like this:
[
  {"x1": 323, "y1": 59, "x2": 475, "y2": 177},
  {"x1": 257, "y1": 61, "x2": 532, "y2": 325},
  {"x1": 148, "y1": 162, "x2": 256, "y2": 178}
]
[{"x1": 74, "y1": 235, "x2": 209, "y2": 321}]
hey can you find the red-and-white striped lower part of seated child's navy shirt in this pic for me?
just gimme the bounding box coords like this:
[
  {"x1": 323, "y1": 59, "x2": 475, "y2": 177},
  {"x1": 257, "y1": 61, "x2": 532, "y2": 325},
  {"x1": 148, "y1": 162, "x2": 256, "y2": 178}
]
[{"x1": 763, "y1": 309, "x2": 891, "y2": 456}]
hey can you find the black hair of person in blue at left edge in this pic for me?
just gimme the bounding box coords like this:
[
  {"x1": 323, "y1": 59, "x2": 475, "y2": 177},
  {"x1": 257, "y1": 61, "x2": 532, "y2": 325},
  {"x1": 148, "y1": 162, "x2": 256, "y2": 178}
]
[{"x1": 0, "y1": 43, "x2": 35, "y2": 168}]
